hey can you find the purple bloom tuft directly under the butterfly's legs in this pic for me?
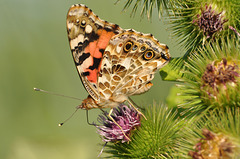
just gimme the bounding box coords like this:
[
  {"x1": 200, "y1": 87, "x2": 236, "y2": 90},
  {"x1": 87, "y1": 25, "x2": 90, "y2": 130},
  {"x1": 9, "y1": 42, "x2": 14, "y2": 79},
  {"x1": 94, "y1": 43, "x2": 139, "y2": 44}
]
[{"x1": 96, "y1": 104, "x2": 141, "y2": 143}]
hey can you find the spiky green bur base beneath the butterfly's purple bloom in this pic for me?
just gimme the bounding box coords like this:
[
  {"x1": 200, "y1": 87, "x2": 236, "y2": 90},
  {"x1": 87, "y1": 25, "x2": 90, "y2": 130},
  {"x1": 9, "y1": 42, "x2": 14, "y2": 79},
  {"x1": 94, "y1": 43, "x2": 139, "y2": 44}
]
[{"x1": 101, "y1": 104, "x2": 187, "y2": 158}]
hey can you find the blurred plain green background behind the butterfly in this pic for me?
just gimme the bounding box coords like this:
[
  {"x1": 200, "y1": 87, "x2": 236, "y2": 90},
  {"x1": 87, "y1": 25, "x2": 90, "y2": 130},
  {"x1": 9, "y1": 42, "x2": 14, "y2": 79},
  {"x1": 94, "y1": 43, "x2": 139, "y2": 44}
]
[{"x1": 0, "y1": 0, "x2": 180, "y2": 159}]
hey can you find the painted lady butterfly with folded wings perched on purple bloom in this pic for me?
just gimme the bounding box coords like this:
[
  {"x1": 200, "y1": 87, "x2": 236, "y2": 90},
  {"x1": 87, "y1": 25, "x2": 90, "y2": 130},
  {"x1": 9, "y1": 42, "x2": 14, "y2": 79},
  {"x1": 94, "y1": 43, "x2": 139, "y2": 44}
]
[{"x1": 67, "y1": 4, "x2": 170, "y2": 140}]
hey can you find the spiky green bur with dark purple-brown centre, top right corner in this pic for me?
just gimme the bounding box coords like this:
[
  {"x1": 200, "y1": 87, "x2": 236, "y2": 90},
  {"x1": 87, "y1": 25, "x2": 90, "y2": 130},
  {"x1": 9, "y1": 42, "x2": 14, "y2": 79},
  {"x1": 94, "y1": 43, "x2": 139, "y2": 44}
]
[{"x1": 170, "y1": 0, "x2": 240, "y2": 55}]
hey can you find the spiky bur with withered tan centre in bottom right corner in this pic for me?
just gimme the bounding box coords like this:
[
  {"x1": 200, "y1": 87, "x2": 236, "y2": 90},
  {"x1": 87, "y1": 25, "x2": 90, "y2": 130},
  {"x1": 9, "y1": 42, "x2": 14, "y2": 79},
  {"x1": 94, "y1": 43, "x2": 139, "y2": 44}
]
[{"x1": 177, "y1": 108, "x2": 240, "y2": 159}]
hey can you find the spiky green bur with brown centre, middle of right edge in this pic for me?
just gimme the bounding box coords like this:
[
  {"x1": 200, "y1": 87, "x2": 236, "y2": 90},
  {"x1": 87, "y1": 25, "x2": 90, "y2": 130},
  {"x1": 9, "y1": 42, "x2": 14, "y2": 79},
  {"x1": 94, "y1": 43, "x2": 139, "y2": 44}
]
[{"x1": 174, "y1": 39, "x2": 240, "y2": 113}]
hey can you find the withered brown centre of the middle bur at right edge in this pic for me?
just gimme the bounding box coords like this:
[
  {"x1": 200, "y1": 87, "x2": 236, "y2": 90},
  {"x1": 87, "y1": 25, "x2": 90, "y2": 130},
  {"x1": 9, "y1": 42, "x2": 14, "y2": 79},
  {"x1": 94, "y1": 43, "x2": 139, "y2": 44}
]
[{"x1": 200, "y1": 58, "x2": 240, "y2": 106}]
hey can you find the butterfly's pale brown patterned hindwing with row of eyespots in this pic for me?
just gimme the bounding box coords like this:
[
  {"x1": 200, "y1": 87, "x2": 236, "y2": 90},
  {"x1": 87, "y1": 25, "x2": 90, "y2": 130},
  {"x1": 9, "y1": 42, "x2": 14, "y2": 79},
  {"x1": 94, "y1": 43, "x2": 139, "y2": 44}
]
[{"x1": 98, "y1": 30, "x2": 170, "y2": 103}]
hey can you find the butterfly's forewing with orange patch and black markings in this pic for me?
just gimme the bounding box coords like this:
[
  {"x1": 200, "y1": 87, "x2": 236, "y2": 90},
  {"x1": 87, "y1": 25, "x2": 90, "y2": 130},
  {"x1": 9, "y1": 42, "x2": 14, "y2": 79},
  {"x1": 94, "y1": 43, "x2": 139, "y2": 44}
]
[{"x1": 67, "y1": 4, "x2": 122, "y2": 101}]
